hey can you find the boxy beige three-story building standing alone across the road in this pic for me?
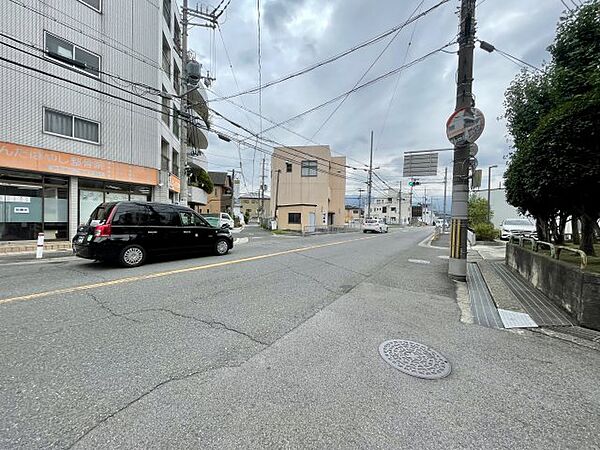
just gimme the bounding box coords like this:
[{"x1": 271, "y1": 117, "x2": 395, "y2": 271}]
[{"x1": 271, "y1": 145, "x2": 346, "y2": 231}]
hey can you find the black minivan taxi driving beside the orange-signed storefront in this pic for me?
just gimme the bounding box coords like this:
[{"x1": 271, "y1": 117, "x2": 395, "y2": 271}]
[{"x1": 73, "y1": 202, "x2": 233, "y2": 267}]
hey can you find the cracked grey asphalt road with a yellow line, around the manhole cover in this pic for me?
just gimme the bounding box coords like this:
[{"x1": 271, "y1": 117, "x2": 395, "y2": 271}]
[{"x1": 0, "y1": 229, "x2": 600, "y2": 448}]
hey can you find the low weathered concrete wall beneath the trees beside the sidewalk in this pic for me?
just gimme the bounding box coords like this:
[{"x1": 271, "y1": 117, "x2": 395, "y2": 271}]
[{"x1": 506, "y1": 244, "x2": 600, "y2": 330}]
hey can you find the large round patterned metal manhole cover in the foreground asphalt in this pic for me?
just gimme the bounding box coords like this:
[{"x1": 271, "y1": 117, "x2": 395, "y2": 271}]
[{"x1": 379, "y1": 339, "x2": 452, "y2": 380}]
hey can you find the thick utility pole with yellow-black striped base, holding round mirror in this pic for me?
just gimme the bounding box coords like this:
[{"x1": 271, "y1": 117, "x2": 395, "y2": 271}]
[{"x1": 448, "y1": 0, "x2": 475, "y2": 281}]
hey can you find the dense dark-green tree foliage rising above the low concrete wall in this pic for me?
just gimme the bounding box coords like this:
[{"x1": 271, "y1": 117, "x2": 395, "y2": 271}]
[{"x1": 505, "y1": 0, "x2": 600, "y2": 255}]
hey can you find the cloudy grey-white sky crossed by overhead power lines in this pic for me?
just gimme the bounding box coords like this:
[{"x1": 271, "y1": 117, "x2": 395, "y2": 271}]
[{"x1": 190, "y1": 0, "x2": 564, "y2": 204}]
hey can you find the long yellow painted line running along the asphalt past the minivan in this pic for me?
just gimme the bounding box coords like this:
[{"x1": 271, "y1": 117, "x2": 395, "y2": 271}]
[{"x1": 0, "y1": 236, "x2": 375, "y2": 305}]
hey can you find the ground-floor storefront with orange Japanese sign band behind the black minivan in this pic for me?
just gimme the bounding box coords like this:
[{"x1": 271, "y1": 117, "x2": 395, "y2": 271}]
[{"x1": 0, "y1": 142, "x2": 158, "y2": 241}]
